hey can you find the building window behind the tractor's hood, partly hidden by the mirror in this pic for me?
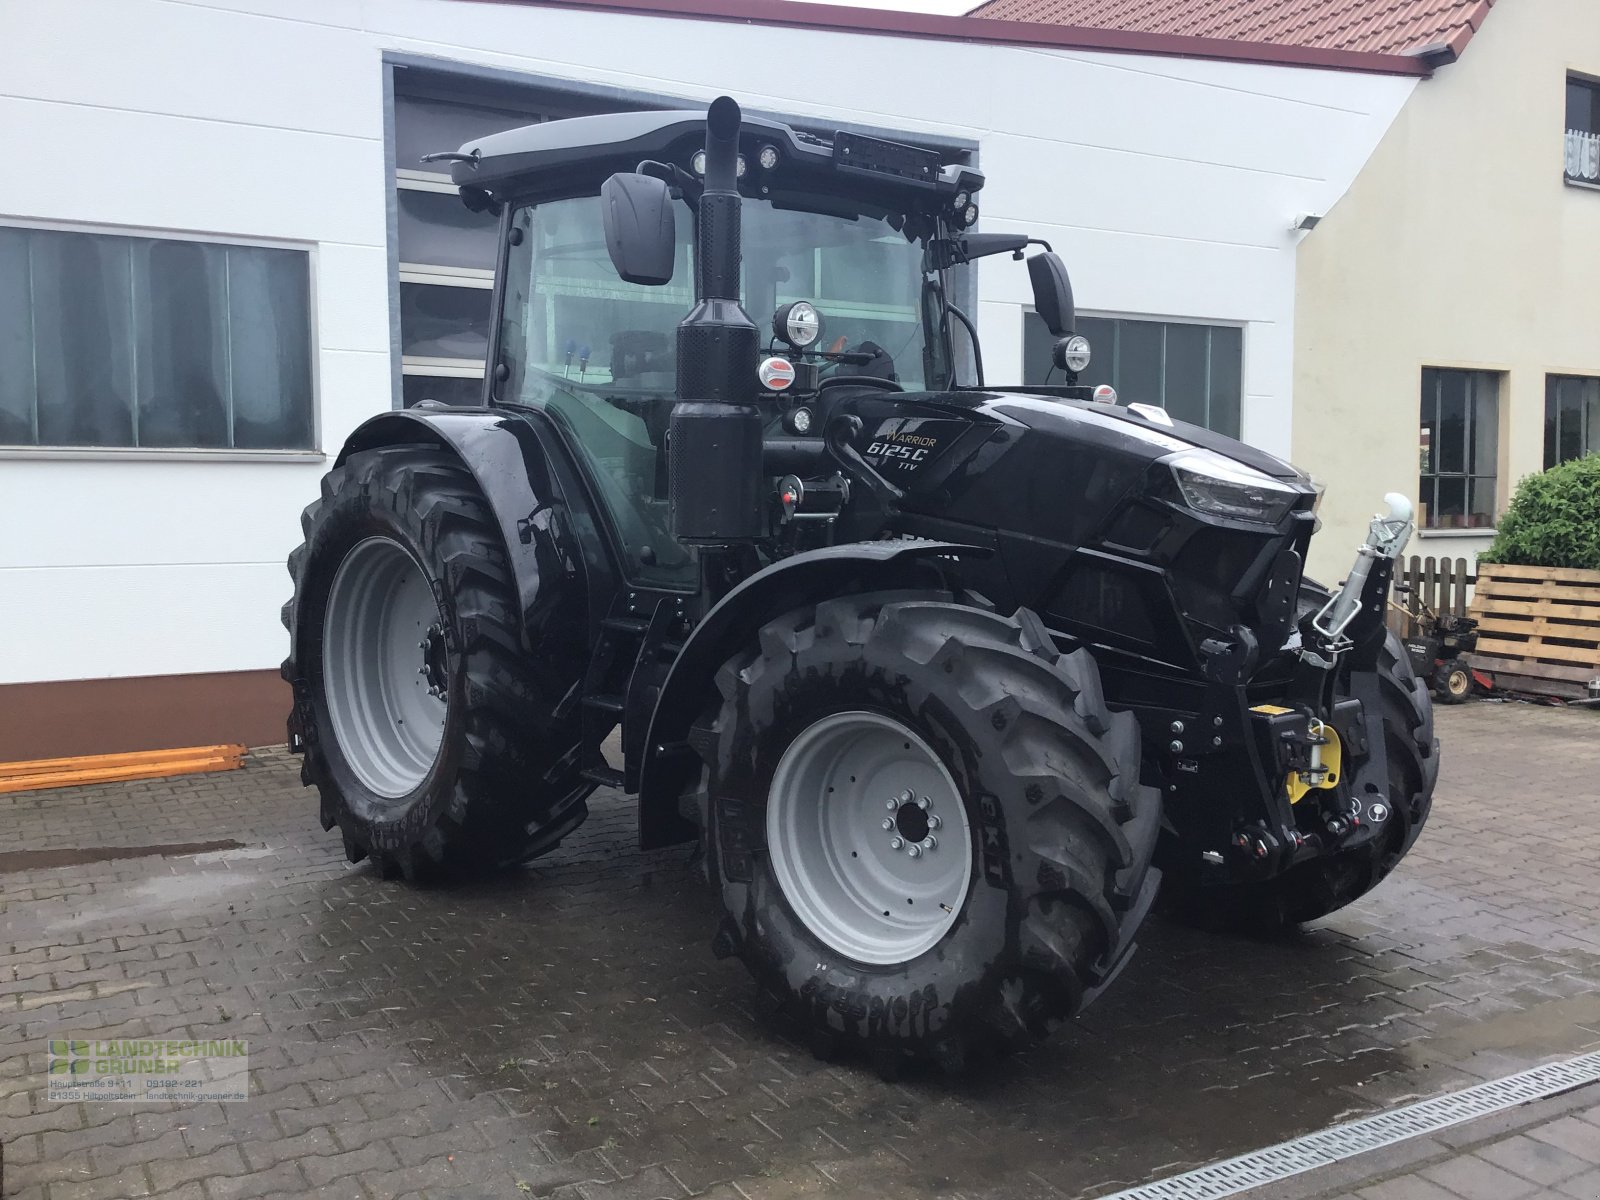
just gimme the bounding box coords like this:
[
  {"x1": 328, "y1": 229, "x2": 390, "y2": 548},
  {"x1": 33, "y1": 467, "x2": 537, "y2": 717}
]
[{"x1": 1022, "y1": 312, "x2": 1245, "y2": 437}]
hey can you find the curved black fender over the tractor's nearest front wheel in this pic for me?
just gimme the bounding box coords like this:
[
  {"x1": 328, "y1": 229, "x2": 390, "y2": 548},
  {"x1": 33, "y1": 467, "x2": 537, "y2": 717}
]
[{"x1": 638, "y1": 539, "x2": 992, "y2": 850}]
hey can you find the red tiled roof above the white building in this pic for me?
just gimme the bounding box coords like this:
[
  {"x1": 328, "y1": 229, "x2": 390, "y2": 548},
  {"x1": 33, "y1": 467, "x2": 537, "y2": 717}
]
[{"x1": 971, "y1": 0, "x2": 1494, "y2": 54}]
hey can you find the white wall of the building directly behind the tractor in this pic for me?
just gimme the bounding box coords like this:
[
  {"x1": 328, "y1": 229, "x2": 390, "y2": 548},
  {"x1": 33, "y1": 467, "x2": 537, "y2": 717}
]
[{"x1": 0, "y1": 0, "x2": 1414, "y2": 683}]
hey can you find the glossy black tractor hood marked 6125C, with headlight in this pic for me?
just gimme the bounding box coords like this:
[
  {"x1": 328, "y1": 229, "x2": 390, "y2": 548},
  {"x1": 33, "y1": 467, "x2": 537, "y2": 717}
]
[{"x1": 842, "y1": 389, "x2": 1317, "y2": 666}]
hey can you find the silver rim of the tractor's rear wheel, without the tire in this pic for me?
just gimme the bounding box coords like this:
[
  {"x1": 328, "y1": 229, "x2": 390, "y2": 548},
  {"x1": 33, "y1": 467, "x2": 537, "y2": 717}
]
[{"x1": 322, "y1": 538, "x2": 450, "y2": 798}]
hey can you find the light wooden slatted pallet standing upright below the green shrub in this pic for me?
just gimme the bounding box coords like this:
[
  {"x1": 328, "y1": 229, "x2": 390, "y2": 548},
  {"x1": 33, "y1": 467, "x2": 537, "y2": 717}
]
[{"x1": 1467, "y1": 563, "x2": 1600, "y2": 699}]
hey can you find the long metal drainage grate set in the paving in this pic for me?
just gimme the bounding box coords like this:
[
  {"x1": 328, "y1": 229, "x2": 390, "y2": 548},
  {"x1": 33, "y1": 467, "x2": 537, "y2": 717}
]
[{"x1": 1101, "y1": 1053, "x2": 1600, "y2": 1200}]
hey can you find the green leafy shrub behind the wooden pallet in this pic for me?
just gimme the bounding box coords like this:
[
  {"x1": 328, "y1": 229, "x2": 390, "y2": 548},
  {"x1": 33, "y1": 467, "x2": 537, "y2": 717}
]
[{"x1": 1478, "y1": 454, "x2": 1600, "y2": 571}]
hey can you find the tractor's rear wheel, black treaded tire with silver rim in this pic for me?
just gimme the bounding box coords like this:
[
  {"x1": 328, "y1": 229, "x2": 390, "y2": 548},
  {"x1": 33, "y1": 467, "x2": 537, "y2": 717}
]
[{"x1": 283, "y1": 446, "x2": 592, "y2": 878}]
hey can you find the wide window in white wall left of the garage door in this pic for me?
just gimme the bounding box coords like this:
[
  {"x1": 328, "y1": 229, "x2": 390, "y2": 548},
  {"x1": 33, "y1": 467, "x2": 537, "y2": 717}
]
[{"x1": 0, "y1": 226, "x2": 315, "y2": 450}]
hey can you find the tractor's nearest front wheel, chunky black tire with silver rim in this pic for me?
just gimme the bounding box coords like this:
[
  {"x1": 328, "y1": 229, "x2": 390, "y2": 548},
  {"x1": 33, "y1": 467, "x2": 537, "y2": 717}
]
[{"x1": 694, "y1": 594, "x2": 1160, "y2": 1067}]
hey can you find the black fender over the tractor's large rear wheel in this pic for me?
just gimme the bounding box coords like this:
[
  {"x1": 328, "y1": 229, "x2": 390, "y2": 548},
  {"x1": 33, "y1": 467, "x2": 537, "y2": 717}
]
[{"x1": 338, "y1": 408, "x2": 611, "y2": 640}]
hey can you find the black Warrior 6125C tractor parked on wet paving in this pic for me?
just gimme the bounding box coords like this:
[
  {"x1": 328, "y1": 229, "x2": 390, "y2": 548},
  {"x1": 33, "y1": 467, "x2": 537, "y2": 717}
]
[{"x1": 283, "y1": 98, "x2": 1438, "y2": 1064}]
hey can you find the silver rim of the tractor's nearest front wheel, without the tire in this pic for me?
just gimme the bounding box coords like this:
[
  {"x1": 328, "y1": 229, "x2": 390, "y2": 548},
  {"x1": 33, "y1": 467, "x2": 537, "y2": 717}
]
[{"x1": 766, "y1": 712, "x2": 973, "y2": 965}]
